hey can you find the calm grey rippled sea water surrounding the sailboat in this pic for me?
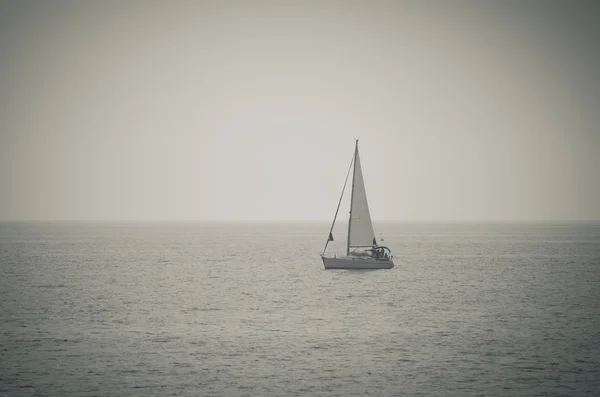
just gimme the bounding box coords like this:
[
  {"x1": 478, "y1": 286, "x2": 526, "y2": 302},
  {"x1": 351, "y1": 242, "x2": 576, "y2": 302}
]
[{"x1": 0, "y1": 223, "x2": 600, "y2": 396}]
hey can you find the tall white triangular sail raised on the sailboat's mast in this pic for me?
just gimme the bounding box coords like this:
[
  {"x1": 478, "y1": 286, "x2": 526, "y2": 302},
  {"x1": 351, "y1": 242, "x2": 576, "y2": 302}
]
[{"x1": 348, "y1": 142, "x2": 375, "y2": 247}]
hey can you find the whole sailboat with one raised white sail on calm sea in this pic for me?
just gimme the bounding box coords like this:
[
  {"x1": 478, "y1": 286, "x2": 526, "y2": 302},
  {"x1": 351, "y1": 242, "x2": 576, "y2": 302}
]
[{"x1": 321, "y1": 139, "x2": 394, "y2": 269}]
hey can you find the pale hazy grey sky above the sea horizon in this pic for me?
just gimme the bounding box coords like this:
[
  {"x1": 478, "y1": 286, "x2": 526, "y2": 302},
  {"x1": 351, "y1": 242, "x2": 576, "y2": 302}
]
[{"x1": 0, "y1": 0, "x2": 600, "y2": 221}]
